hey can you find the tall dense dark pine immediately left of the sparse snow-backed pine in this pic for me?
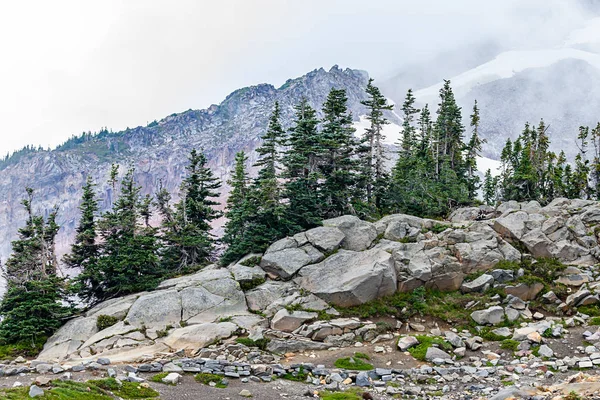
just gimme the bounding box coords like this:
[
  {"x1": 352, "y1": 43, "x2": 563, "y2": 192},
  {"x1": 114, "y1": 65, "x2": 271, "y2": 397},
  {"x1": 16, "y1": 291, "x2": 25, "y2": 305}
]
[{"x1": 319, "y1": 89, "x2": 357, "y2": 218}]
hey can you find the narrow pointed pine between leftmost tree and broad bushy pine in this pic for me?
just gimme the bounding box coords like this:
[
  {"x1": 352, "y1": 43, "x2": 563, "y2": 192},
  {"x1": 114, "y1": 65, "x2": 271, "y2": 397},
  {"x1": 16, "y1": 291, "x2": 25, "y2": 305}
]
[{"x1": 63, "y1": 176, "x2": 102, "y2": 303}]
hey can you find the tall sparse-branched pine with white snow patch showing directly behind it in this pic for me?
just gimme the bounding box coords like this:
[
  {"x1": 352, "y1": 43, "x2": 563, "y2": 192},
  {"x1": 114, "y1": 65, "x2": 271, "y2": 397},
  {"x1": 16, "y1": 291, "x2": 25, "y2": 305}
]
[{"x1": 359, "y1": 78, "x2": 394, "y2": 210}]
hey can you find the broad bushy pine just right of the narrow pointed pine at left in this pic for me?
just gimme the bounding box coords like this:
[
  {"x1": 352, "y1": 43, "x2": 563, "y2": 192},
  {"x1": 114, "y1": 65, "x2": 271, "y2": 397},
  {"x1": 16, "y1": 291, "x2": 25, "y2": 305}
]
[{"x1": 94, "y1": 169, "x2": 163, "y2": 301}]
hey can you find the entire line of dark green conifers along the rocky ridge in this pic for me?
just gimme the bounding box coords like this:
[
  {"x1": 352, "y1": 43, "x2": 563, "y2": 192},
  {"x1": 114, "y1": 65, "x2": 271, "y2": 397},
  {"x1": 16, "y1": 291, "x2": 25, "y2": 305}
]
[{"x1": 0, "y1": 79, "x2": 600, "y2": 349}]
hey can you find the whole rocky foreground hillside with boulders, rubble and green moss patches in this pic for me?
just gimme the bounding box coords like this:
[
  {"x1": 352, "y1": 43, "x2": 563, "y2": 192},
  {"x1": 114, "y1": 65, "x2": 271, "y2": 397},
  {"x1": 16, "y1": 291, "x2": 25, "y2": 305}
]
[{"x1": 18, "y1": 199, "x2": 600, "y2": 399}]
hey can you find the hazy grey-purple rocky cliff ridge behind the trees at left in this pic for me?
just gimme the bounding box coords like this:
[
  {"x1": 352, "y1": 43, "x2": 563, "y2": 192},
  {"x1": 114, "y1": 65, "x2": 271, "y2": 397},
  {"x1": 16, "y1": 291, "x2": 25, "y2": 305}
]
[{"x1": 0, "y1": 66, "x2": 376, "y2": 268}]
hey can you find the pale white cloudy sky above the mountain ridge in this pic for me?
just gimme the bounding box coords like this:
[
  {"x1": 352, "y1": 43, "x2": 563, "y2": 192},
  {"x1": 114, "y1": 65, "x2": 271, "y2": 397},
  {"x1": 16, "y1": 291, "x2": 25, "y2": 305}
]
[{"x1": 0, "y1": 0, "x2": 595, "y2": 155}]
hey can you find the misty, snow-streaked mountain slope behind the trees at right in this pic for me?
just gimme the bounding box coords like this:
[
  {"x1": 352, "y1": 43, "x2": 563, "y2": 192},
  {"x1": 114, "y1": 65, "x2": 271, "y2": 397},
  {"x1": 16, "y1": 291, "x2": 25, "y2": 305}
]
[{"x1": 382, "y1": 18, "x2": 600, "y2": 159}]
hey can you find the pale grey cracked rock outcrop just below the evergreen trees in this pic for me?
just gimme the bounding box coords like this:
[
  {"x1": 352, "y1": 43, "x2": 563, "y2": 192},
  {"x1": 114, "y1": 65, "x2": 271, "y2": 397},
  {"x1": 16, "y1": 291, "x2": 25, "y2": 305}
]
[{"x1": 40, "y1": 199, "x2": 600, "y2": 361}]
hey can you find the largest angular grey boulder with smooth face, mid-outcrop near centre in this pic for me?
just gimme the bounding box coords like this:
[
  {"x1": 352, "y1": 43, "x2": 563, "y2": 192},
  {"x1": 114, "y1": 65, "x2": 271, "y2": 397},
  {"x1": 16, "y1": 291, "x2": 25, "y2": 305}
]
[{"x1": 296, "y1": 249, "x2": 396, "y2": 307}]
